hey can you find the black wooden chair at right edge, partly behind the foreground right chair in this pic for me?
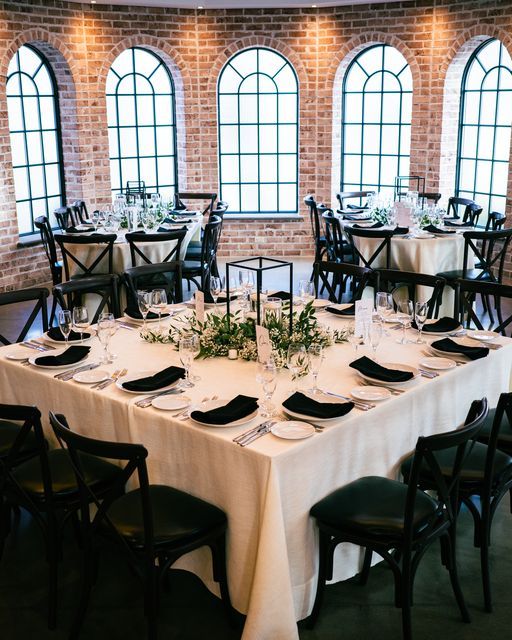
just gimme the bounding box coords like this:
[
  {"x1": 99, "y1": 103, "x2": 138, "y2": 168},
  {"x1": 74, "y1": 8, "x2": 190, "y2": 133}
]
[{"x1": 401, "y1": 393, "x2": 512, "y2": 613}]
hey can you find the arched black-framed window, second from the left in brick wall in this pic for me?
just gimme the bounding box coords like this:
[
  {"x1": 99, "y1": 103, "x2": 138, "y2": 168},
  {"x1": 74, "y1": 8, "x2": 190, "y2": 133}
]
[{"x1": 106, "y1": 47, "x2": 177, "y2": 198}]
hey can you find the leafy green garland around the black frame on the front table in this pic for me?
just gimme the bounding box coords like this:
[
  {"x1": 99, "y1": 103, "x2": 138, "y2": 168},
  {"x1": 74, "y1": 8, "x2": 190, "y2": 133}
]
[{"x1": 142, "y1": 302, "x2": 350, "y2": 368}]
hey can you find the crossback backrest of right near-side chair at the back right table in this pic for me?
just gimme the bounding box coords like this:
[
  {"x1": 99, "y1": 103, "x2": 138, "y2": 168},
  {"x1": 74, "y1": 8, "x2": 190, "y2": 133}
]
[{"x1": 462, "y1": 229, "x2": 512, "y2": 282}]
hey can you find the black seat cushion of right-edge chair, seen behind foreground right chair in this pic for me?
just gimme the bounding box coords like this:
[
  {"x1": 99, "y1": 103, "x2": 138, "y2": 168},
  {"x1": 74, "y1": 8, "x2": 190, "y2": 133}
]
[{"x1": 401, "y1": 442, "x2": 512, "y2": 491}]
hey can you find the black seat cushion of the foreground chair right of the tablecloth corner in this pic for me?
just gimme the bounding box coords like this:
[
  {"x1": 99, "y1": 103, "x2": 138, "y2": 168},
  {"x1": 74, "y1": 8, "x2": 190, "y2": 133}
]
[{"x1": 311, "y1": 476, "x2": 438, "y2": 539}]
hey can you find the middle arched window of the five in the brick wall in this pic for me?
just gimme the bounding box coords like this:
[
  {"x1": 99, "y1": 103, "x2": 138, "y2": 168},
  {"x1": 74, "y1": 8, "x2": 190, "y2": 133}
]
[{"x1": 218, "y1": 48, "x2": 298, "y2": 214}]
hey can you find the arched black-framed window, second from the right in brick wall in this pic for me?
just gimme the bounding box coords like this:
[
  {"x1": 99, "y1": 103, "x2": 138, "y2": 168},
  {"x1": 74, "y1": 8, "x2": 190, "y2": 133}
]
[{"x1": 341, "y1": 45, "x2": 412, "y2": 191}]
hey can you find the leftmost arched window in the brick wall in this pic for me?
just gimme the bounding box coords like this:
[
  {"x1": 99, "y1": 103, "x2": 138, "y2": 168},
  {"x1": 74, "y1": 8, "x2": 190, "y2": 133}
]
[{"x1": 7, "y1": 45, "x2": 64, "y2": 235}]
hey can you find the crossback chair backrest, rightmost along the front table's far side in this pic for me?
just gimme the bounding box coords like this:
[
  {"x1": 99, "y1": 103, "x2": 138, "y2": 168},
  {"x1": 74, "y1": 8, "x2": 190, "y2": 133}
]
[{"x1": 455, "y1": 279, "x2": 512, "y2": 335}]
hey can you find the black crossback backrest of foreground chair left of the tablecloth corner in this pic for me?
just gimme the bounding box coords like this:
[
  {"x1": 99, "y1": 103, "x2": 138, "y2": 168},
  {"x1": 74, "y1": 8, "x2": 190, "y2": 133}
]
[{"x1": 50, "y1": 412, "x2": 153, "y2": 554}]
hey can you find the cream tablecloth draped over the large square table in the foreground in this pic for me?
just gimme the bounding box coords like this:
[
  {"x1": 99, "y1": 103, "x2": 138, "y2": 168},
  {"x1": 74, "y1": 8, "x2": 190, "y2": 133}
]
[{"x1": 0, "y1": 312, "x2": 512, "y2": 640}]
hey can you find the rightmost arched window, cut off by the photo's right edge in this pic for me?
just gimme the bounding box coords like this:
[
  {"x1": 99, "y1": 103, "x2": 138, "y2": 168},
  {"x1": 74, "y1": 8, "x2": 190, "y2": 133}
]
[{"x1": 456, "y1": 40, "x2": 512, "y2": 213}]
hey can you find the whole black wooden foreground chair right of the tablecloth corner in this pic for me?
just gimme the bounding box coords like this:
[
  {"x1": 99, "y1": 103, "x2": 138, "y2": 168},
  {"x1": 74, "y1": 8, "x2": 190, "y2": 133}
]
[{"x1": 306, "y1": 399, "x2": 488, "y2": 640}]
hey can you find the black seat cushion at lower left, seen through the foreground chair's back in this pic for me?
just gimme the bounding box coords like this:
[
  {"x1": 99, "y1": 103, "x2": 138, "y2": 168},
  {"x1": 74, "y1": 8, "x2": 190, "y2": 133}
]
[{"x1": 13, "y1": 449, "x2": 121, "y2": 500}]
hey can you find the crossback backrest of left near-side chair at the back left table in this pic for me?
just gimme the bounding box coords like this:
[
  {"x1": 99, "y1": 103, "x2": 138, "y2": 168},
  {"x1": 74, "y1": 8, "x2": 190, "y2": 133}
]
[{"x1": 54, "y1": 233, "x2": 117, "y2": 280}]
